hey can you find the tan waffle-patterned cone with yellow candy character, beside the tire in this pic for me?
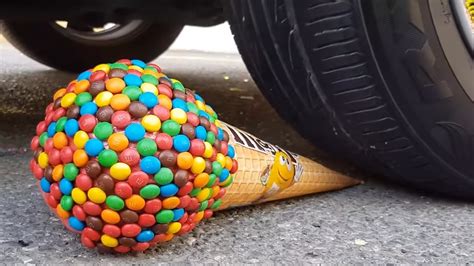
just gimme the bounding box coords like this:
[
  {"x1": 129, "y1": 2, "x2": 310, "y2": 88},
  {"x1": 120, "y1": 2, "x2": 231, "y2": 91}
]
[{"x1": 219, "y1": 123, "x2": 361, "y2": 210}]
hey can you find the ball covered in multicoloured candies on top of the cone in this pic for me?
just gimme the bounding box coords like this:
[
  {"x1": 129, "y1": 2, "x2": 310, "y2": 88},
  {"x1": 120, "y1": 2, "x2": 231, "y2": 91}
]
[{"x1": 30, "y1": 59, "x2": 237, "y2": 253}]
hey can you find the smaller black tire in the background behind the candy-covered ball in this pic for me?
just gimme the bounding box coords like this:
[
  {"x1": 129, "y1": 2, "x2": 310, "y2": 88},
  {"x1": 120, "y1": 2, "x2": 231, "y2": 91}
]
[{"x1": 2, "y1": 21, "x2": 183, "y2": 72}]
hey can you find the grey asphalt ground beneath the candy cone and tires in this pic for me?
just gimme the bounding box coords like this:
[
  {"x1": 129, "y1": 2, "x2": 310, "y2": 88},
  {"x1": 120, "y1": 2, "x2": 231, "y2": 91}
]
[{"x1": 0, "y1": 35, "x2": 474, "y2": 264}]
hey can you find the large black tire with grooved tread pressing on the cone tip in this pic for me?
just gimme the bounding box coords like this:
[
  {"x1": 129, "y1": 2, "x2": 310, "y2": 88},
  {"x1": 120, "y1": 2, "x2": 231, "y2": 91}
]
[{"x1": 223, "y1": 0, "x2": 474, "y2": 199}]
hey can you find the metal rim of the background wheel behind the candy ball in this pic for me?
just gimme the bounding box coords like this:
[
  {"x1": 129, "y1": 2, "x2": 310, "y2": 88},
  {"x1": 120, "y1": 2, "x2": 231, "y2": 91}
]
[{"x1": 50, "y1": 20, "x2": 150, "y2": 46}]
